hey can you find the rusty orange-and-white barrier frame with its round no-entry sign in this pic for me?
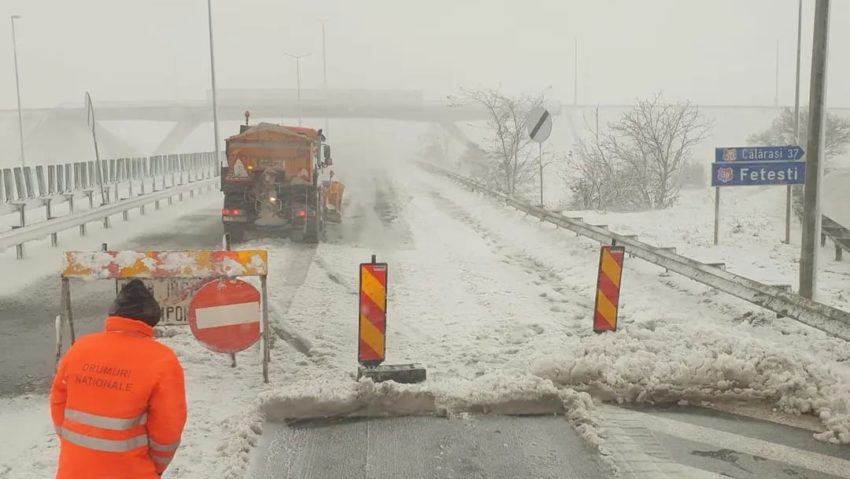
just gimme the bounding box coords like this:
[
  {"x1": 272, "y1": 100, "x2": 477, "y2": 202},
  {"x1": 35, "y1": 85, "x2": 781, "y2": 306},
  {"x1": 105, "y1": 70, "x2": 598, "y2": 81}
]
[{"x1": 62, "y1": 250, "x2": 270, "y2": 383}]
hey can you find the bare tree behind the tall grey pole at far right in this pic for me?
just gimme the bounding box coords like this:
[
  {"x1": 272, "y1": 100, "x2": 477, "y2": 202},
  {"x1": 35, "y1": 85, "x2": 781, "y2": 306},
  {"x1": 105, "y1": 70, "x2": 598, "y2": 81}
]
[{"x1": 747, "y1": 108, "x2": 850, "y2": 159}]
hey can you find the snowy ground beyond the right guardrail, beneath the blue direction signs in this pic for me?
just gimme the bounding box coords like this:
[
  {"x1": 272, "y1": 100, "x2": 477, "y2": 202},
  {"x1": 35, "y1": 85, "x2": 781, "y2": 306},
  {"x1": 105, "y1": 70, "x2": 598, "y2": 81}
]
[{"x1": 565, "y1": 183, "x2": 850, "y2": 310}]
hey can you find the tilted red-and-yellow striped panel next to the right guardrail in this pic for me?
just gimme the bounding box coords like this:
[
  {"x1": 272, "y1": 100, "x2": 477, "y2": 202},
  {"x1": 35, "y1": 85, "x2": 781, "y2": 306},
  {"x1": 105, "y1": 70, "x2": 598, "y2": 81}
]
[{"x1": 593, "y1": 246, "x2": 626, "y2": 333}]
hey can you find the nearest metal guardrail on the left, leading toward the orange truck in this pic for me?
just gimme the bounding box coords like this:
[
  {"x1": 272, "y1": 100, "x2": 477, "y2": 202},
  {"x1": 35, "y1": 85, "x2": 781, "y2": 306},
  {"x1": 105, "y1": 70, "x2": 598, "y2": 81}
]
[{"x1": 0, "y1": 178, "x2": 218, "y2": 259}]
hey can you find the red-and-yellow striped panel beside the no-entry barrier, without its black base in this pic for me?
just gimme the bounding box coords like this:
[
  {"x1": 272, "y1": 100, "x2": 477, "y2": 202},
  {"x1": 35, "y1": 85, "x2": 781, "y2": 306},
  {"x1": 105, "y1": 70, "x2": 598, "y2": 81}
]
[{"x1": 357, "y1": 258, "x2": 387, "y2": 367}]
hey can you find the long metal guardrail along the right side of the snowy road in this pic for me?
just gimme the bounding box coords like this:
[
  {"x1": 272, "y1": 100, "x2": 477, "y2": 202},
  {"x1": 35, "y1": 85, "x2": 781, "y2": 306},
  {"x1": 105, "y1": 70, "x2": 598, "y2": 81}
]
[{"x1": 420, "y1": 162, "x2": 850, "y2": 341}]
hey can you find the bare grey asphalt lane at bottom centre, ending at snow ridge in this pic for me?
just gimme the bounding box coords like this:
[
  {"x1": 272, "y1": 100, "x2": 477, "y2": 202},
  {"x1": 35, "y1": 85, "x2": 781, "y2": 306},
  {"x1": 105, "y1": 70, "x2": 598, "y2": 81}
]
[{"x1": 246, "y1": 416, "x2": 609, "y2": 479}]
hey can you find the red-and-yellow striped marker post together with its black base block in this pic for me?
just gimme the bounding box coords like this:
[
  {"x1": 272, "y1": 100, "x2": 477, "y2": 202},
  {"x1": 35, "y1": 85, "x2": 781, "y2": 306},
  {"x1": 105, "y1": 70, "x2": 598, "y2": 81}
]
[{"x1": 357, "y1": 255, "x2": 426, "y2": 383}]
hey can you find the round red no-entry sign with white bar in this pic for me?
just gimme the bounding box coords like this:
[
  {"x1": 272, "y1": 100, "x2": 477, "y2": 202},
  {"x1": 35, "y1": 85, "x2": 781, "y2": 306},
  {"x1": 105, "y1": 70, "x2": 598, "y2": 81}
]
[{"x1": 189, "y1": 279, "x2": 261, "y2": 353}]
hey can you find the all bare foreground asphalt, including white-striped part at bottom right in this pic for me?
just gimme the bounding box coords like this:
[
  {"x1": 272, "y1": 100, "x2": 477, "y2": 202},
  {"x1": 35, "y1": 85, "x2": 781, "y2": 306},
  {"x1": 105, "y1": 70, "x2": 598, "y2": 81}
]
[{"x1": 246, "y1": 406, "x2": 850, "y2": 479}]
